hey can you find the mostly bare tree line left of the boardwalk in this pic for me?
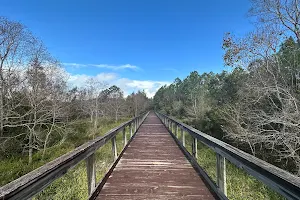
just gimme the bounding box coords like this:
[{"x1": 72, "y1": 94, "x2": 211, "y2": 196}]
[{"x1": 0, "y1": 17, "x2": 150, "y2": 163}]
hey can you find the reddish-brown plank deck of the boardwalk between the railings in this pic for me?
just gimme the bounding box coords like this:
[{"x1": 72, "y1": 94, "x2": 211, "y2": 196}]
[{"x1": 97, "y1": 113, "x2": 215, "y2": 200}]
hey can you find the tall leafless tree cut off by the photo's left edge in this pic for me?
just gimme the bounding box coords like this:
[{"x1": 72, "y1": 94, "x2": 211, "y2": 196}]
[{"x1": 0, "y1": 17, "x2": 34, "y2": 136}]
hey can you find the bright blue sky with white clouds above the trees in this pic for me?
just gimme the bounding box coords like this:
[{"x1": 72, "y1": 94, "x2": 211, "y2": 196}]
[{"x1": 0, "y1": 0, "x2": 252, "y2": 96}]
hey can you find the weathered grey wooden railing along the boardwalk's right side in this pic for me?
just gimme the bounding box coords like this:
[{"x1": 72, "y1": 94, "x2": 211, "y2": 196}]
[{"x1": 156, "y1": 113, "x2": 300, "y2": 200}]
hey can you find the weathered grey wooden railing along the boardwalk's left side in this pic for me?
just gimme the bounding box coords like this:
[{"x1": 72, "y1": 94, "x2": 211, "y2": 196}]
[{"x1": 0, "y1": 113, "x2": 148, "y2": 200}]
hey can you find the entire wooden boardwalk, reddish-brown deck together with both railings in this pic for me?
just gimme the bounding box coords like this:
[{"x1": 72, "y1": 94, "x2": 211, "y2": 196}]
[{"x1": 0, "y1": 112, "x2": 300, "y2": 200}]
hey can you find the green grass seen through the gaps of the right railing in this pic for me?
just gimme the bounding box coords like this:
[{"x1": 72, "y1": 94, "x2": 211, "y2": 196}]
[{"x1": 178, "y1": 130, "x2": 285, "y2": 200}]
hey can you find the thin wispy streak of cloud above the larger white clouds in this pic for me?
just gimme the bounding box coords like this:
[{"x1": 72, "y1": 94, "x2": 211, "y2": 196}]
[{"x1": 63, "y1": 63, "x2": 140, "y2": 70}]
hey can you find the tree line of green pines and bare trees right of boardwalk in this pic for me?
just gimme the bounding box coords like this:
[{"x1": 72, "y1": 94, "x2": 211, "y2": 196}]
[{"x1": 153, "y1": 0, "x2": 300, "y2": 175}]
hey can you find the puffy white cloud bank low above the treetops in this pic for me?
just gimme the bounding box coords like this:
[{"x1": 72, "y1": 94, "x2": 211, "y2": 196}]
[{"x1": 64, "y1": 73, "x2": 170, "y2": 97}]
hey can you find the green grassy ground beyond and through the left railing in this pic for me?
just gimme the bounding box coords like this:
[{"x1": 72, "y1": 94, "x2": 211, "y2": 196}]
[{"x1": 0, "y1": 119, "x2": 130, "y2": 200}]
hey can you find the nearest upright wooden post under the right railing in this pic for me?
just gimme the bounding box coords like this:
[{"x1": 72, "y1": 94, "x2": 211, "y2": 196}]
[{"x1": 216, "y1": 153, "x2": 227, "y2": 196}]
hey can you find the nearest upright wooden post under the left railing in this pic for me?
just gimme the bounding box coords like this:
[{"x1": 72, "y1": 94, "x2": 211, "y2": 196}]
[{"x1": 86, "y1": 153, "x2": 96, "y2": 195}]
